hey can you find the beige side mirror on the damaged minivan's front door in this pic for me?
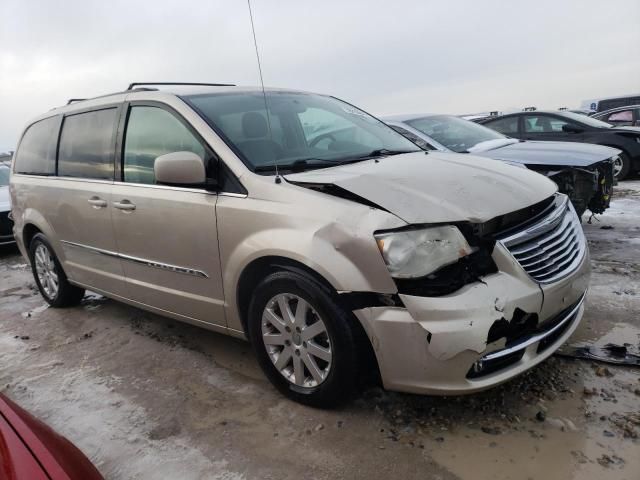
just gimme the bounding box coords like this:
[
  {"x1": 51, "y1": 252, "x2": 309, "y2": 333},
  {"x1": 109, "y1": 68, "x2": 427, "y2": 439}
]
[{"x1": 153, "y1": 152, "x2": 207, "y2": 186}]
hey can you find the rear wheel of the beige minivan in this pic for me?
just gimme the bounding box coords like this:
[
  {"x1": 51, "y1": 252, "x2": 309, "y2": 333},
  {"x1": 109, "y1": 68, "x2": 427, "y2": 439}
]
[{"x1": 29, "y1": 233, "x2": 84, "y2": 308}]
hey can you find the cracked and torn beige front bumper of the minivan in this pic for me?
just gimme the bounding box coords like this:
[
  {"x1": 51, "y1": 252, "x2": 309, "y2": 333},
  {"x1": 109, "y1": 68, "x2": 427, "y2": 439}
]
[{"x1": 354, "y1": 251, "x2": 589, "y2": 395}]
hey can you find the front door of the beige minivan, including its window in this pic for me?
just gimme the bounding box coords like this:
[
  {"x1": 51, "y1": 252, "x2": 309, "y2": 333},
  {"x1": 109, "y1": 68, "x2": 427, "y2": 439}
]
[{"x1": 112, "y1": 103, "x2": 225, "y2": 325}]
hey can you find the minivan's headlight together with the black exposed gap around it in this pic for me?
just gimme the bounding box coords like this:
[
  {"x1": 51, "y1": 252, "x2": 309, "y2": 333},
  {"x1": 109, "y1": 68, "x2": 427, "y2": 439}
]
[{"x1": 375, "y1": 225, "x2": 497, "y2": 296}]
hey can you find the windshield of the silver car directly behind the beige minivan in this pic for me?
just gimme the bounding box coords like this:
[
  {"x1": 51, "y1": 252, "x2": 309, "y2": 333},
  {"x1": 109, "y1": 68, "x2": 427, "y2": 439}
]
[{"x1": 407, "y1": 115, "x2": 508, "y2": 153}]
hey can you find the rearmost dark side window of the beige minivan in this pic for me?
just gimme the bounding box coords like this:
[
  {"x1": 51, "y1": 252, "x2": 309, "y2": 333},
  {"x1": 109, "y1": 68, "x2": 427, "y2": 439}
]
[{"x1": 15, "y1": 117, "x2": 60, "y2": 175}]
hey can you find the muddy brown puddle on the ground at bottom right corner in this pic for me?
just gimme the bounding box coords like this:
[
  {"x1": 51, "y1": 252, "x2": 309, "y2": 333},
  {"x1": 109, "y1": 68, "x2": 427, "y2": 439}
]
[{"x1": 429, "y1": 367, "x2": 640, "y2": 480}]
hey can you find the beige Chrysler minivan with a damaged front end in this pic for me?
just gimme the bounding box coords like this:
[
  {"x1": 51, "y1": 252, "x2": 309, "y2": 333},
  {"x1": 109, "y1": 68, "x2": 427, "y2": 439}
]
[{"x1": 11, "y1": 84, "x2": 589, "y2": 407}]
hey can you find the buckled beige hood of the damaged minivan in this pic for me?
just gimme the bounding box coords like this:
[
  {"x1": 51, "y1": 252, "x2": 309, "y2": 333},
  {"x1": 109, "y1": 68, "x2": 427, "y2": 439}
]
[{"x1": 284, "y1": 152, "x2": 556, "y2": 223}]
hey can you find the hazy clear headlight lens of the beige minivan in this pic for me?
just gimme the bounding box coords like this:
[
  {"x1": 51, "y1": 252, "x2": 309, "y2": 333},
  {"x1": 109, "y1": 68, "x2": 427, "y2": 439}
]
[{"x1": 375, "y1": 225, "x2": 474, "y2": 278}]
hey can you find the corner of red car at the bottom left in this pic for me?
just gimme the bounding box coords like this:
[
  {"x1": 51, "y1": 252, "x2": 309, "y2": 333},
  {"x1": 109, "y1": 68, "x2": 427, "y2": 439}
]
[{"x1": 0, "y1": 393, "x2": 102, "y2": 480}]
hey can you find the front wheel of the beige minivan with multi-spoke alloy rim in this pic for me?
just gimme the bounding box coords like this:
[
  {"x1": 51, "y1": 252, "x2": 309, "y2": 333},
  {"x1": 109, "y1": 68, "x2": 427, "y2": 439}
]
[{"x1": 248, "y1": 271, "x2": 360, "y2": 408}]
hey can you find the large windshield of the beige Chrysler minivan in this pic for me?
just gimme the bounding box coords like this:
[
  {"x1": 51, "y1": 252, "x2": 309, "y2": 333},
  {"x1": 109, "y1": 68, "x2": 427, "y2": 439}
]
[{"x1": 184, "y1": 91, "x2": 420, "y2": 172}]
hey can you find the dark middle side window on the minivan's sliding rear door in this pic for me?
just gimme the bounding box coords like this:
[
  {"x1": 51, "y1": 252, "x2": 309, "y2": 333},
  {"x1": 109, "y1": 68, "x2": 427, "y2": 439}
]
[{"x1": 58, "y1": 108, "x2": 117, "y2": 180}]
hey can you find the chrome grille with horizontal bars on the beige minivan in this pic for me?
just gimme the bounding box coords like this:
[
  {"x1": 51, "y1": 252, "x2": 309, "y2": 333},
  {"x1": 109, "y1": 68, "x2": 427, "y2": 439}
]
[{"x1": 499, "y1": 195, "x2": 587, "y2": 283}]
